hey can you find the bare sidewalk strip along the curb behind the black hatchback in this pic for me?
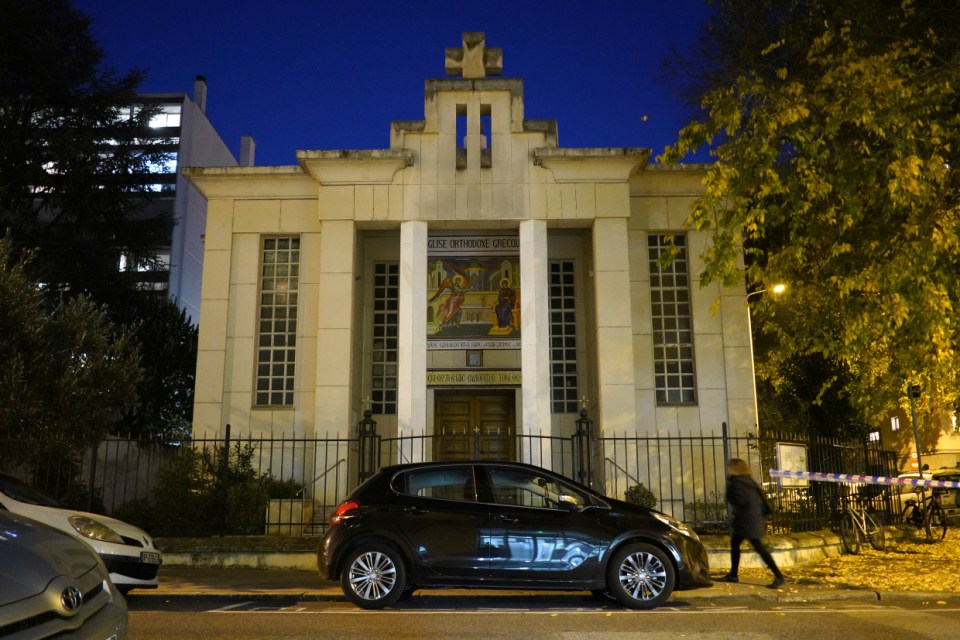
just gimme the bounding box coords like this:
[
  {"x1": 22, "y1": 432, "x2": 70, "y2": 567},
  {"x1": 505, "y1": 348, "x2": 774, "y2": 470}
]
[{"x1": 130, "y1": 567, "x2": 884, "y2": 604}]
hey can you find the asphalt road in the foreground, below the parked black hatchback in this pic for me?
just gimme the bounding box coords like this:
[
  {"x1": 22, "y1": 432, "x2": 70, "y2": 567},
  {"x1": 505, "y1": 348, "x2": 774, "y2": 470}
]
[{"x1": 130, "y1": 595, "x2": 960, "y2": 640}]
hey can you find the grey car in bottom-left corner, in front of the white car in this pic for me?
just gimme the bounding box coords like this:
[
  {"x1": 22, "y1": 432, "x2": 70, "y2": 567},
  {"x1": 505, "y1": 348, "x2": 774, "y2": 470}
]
[{"x1": 0, "y1": 510, "x2": 127, "y2": 640}]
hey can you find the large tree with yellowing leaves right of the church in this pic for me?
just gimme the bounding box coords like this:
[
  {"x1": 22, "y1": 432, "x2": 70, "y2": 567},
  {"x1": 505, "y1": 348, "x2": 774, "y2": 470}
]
[{"x1": 663, "y1": 0, "x2": 960, "y2": 432}]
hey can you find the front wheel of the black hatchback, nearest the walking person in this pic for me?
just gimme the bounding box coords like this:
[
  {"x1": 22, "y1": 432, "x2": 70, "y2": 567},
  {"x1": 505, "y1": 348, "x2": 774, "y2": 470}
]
[{"x1": 607, "y1": 543, "x2": 676, "y2": 609}]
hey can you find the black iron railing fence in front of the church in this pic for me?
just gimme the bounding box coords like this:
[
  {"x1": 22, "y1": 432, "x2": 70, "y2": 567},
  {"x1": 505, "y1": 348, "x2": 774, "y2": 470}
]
[{"x1": 0, "y1": 416, "x2": 900, "y2": 536}]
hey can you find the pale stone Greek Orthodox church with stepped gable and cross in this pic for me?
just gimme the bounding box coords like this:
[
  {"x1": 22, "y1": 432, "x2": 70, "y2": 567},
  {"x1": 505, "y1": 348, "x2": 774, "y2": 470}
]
[{"x1": 184, "y1": 33, "x2": 756, "y2": 466}]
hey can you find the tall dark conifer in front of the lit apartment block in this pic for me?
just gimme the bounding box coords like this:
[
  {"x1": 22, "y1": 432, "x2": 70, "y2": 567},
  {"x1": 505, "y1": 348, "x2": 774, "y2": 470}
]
[{"x1": 0, "y1": 0, "x2": 196, "y2": 440}]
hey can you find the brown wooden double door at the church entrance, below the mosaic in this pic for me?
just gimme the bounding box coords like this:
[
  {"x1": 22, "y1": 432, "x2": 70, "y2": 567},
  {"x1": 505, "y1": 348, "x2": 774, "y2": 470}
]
[{"x1": 433, "y1": 390, "x2": 516, "y2": 460}]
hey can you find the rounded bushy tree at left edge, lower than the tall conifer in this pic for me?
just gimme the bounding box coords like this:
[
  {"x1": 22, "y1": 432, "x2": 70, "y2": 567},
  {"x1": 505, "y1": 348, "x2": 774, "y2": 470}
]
[{"x1": 0, "y1": 238, "x2": 141, "y2": 456}]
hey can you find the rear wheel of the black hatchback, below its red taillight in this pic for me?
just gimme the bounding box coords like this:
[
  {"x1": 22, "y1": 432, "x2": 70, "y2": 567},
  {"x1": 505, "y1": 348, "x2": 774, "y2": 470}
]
[{"x1": 340, "y1": 544, "x2": 406, "y2": 609}]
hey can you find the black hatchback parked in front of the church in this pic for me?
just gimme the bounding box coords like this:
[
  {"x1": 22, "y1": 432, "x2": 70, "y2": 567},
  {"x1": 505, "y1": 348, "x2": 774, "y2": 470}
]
[{"x1": 318, "y1": 462, "x2": 710, "y2": 609}]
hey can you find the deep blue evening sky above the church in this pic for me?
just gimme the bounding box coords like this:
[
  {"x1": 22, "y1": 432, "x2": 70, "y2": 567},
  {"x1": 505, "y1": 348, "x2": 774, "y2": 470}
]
[{"x1": 75, "y1": 0, "x2": 707, "y2": 165}]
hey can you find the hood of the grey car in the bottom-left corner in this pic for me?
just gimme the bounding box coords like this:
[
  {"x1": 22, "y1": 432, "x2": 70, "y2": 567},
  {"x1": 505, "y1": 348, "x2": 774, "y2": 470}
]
[{"x1": 0, "y1": 512, "x2": 99, "y2": 606}]
